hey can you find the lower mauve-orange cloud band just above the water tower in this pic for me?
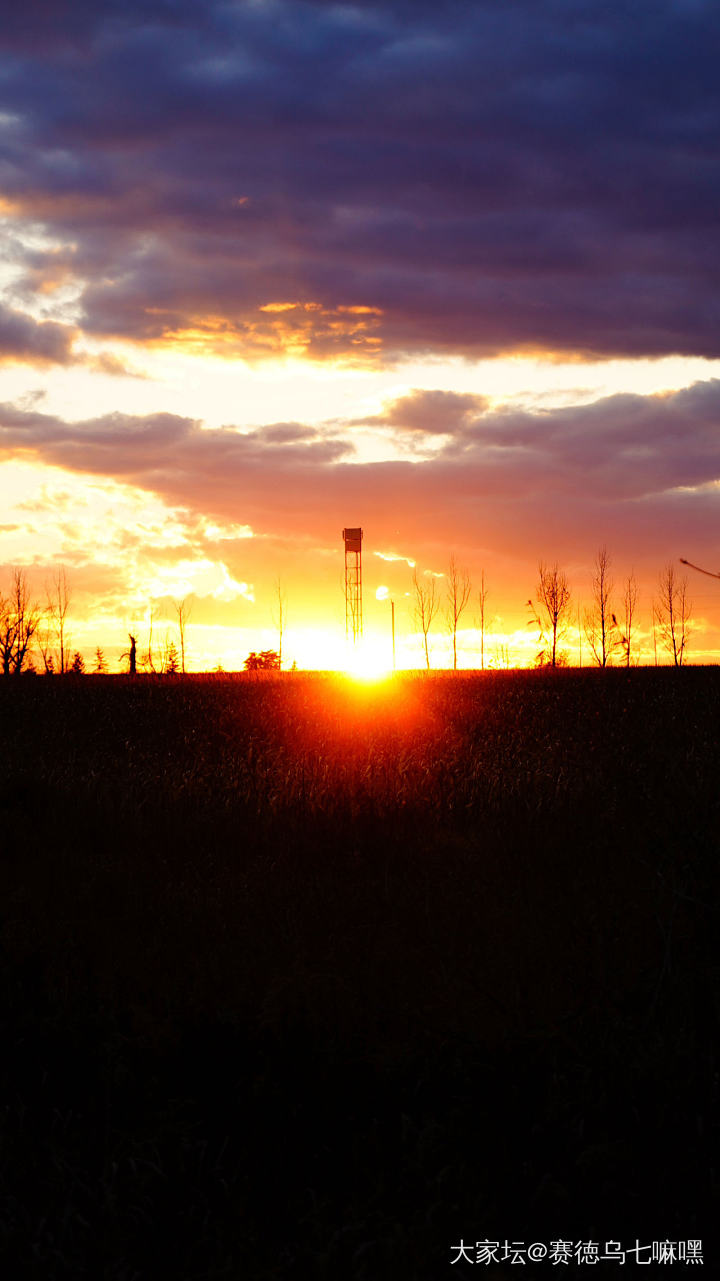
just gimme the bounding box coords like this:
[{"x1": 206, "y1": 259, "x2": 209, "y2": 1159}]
[{"x1": 0, "y1": 380, "x2": 720, "y2": 555}]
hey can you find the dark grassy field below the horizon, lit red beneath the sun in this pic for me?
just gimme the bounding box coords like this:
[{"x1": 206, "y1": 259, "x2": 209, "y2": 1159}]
[{"x1": 0, "y1": 669, "x2": 720, "y2": 1281}]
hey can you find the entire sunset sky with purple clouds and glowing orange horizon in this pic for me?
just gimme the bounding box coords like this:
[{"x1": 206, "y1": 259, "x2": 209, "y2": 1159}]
[{"x1": 0, "y1": 0, "x2": 720, "y2": 670}]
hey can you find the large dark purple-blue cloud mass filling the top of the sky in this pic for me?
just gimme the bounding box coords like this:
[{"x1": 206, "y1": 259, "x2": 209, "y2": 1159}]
[{"x1": 0, "y1": 0, "x2": 720, "y2": 360}]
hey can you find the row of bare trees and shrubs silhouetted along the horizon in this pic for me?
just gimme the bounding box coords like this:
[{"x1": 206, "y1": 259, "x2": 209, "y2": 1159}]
[{"x1": 0, "y1": 547, "x2": 692, "y2": 675}]
